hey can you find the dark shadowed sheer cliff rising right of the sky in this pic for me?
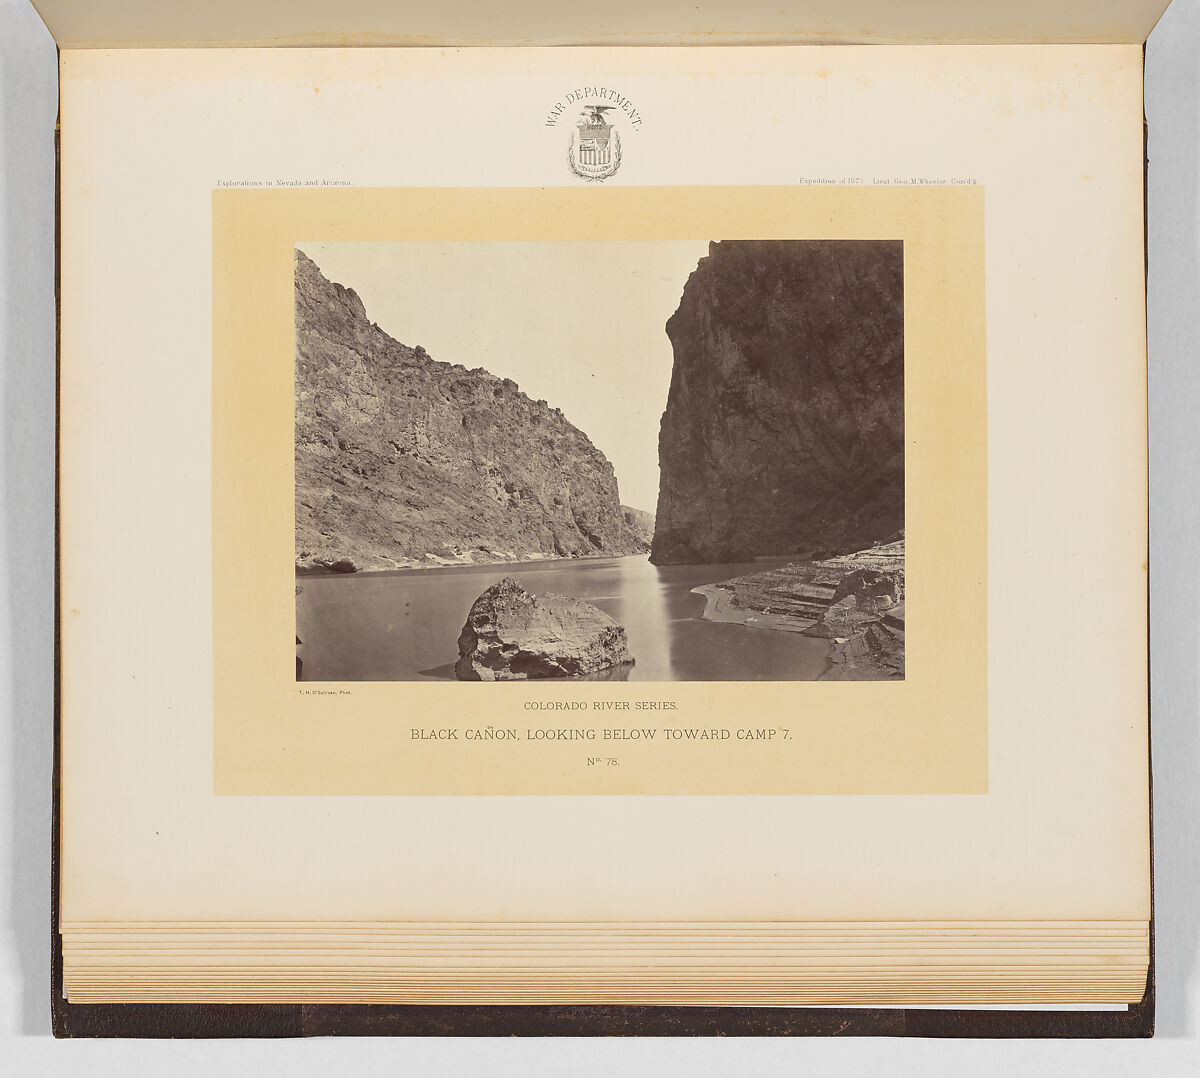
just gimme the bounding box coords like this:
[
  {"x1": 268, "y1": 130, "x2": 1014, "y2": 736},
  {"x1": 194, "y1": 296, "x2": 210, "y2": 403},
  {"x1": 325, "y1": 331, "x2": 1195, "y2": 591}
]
[{"x1": 650, "y1": 240, "x2": 904, "y2": 564}]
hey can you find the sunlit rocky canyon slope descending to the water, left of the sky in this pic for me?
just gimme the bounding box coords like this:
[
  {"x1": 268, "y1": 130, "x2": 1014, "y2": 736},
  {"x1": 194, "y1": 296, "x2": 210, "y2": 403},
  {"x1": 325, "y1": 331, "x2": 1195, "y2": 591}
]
[{"x1": 295, "y1": 251, "x2": 648, "y2": 571}]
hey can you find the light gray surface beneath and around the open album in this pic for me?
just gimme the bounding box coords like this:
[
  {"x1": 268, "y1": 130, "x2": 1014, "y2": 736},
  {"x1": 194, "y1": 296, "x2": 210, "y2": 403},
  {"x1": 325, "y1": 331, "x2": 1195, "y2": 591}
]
[{"x1": 0, "y1": 0, "x2": 1200, "y2": 1078}]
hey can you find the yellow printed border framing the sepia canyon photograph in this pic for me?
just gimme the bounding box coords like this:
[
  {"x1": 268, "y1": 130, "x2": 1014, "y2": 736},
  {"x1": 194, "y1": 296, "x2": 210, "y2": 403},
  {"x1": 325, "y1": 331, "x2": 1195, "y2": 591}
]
[{"x1": 212, "y1": 186, "x2": 988, "y2": 795}]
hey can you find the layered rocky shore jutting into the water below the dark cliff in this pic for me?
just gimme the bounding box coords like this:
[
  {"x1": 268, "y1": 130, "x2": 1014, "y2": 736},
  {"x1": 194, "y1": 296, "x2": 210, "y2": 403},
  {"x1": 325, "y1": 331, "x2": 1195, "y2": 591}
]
[{"x1": 692, "y1": 538, "x2": 905, "y2": 681}]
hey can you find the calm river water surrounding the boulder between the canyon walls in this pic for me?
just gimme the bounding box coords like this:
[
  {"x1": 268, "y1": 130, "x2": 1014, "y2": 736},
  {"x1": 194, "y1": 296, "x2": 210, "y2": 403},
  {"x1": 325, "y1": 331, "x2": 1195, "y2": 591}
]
[{"x1": 296, "y1": 555, "x2": 829, "y2": 681}]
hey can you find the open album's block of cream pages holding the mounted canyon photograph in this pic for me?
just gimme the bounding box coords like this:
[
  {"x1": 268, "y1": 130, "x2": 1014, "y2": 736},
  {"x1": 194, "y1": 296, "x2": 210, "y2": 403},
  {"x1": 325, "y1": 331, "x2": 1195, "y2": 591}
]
[{"x1": 40, "y1": 0, "x2": 1160, "y2": 1032}]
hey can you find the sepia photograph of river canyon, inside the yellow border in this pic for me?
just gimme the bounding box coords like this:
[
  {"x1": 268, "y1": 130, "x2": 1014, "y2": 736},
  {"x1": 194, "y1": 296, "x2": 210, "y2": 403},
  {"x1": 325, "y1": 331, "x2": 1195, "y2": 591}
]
[{"x1": 295, "y1": 239, "x2": 905, "y2": 682}]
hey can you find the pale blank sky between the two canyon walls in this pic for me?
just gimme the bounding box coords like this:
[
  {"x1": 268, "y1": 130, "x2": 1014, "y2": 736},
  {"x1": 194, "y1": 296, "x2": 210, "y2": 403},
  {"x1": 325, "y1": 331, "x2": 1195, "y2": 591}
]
[{"x1": 296, "y1": 240, "x2": 708, "y2": 513}]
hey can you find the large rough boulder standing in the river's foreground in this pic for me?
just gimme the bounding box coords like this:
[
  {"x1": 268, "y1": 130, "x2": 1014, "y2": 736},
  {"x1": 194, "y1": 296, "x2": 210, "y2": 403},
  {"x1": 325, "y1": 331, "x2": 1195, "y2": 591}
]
[{"x1": 455, "y1": 576, "x2": 634, "y2": 681}]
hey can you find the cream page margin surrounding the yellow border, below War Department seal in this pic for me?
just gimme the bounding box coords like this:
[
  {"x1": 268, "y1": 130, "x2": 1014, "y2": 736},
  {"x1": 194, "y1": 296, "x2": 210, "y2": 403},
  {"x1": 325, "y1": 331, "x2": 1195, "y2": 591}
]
[{"x1": 60, "y1": 46, "x2": 1150, "y2": 923}]
